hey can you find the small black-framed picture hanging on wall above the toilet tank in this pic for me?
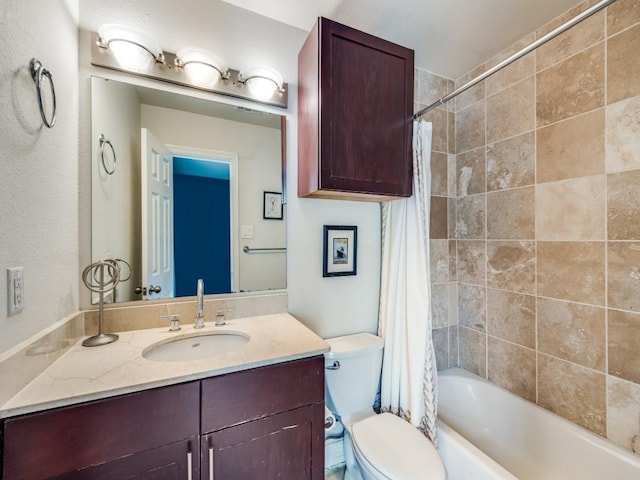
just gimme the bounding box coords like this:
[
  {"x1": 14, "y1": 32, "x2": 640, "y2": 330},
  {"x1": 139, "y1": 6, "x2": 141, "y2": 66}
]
[{"x1": 322, "y1": 225, "x2": 358, "y2": 277}]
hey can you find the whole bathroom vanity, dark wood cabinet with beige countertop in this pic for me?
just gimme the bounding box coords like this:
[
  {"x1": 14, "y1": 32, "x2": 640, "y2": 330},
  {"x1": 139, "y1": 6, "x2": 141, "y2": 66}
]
[{"x1": 2, "y1": 314, "x2": 327, "y2": 480}]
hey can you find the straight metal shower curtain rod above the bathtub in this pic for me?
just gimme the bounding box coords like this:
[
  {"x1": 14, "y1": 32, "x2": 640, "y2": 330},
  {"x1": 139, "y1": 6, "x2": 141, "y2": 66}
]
[{"x1": 413, "y1": 0, "x2": 616, "y2": 120}]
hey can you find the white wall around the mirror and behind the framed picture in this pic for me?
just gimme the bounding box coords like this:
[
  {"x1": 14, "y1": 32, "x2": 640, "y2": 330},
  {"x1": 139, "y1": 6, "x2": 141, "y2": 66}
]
[{"x1": 80, "y1": 4, "x2": 380, "y2": 337}]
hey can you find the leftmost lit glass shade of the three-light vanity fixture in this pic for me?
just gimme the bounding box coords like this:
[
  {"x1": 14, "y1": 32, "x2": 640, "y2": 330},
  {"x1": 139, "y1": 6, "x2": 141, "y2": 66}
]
[{"x1": 97, "y1": 23, "x2": 164, "y2": 71}]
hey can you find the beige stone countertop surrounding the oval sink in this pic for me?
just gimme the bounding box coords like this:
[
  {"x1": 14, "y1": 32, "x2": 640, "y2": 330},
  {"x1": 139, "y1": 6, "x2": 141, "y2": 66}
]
[{"x1": 0, "y1": 313, "x2": 329, "y2": 418}]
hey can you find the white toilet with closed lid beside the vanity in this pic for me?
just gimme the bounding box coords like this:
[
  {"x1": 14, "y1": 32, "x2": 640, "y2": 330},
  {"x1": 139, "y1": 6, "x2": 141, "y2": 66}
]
[{"x1": 325, "y1": 333, "x2": 447, "y2": 480}]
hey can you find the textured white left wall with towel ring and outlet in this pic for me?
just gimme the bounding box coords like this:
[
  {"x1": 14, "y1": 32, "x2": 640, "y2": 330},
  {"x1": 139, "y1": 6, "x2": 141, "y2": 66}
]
[{"x1": 0, "y1": 0, "x2": 79, "y2": 355}]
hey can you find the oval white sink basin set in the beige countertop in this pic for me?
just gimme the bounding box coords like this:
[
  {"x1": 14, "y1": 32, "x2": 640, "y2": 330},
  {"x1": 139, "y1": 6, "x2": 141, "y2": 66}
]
[{"x1": 142, "y1": 331, "x2": 250, "y2": 362}]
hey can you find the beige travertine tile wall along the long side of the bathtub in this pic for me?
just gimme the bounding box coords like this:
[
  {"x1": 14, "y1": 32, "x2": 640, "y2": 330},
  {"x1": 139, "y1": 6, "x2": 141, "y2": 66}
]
[{"x1": 450, "y1": 0, "x2": 640, "y2": 448}]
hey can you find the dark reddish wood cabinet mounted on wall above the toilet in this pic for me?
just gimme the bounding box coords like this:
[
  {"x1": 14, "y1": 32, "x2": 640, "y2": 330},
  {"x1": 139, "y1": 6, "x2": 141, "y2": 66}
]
[{"x1": 298, "y1": 18, "x2": 414, "y2": 201}]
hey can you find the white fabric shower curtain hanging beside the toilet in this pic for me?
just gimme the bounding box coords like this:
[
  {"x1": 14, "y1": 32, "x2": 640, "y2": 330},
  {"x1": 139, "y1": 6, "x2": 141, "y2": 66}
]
[{"x1": 378, "y1": 122, "x2": 437, "y2": 446}]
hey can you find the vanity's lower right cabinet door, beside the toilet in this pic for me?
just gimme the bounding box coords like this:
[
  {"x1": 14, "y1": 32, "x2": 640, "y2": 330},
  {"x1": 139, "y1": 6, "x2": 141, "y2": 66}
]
[{"x1": 200, "y1": 404, "x2": 324, "y2": 480}]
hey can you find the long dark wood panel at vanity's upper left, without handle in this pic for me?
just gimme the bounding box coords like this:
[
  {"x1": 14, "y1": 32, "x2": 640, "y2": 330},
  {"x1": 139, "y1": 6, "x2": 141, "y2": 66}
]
[{"x1": 2, "y1": 382, "x2": 200, "y2": 480}]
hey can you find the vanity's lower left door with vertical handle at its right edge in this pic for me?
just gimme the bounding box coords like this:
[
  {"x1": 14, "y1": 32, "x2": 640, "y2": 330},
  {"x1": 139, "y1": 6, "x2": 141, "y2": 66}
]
[{"x1": 53, "y1": 437, "x2": 200, "y2": 480}]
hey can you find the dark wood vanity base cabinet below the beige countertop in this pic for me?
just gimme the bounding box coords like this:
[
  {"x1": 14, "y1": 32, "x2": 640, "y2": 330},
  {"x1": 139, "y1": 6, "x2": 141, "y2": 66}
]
[{"x1": 1, "y1": 356, "x2": 324, "y2": 480}]
